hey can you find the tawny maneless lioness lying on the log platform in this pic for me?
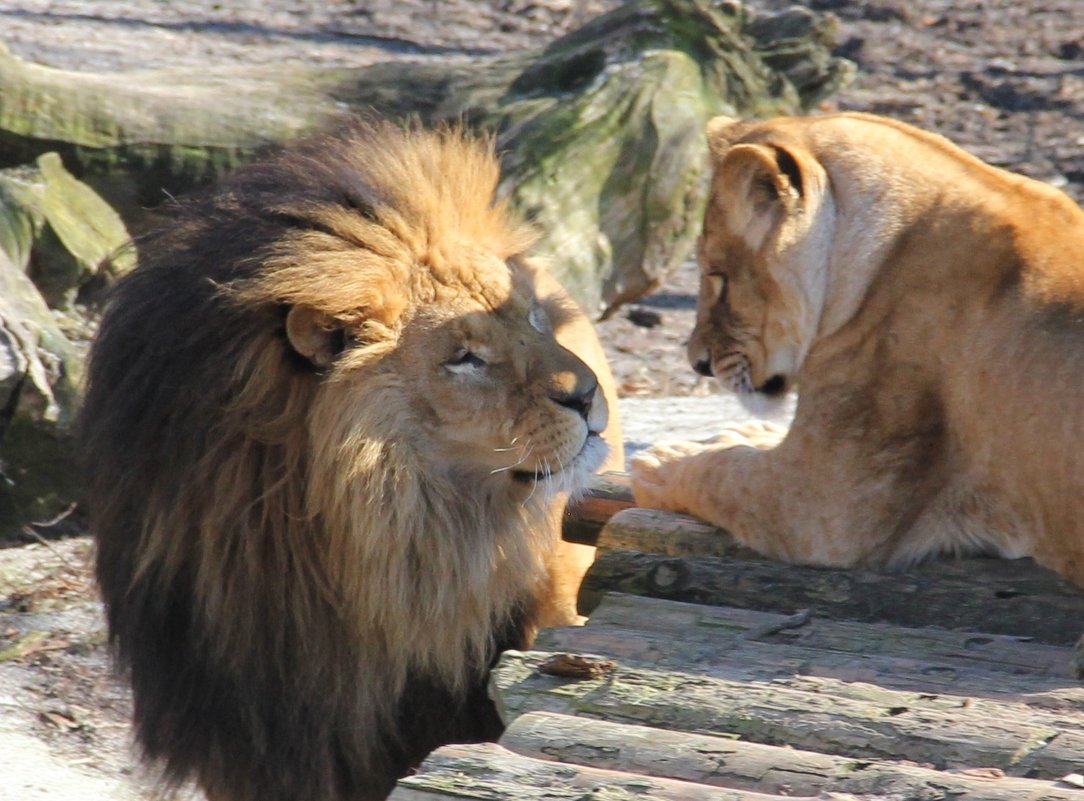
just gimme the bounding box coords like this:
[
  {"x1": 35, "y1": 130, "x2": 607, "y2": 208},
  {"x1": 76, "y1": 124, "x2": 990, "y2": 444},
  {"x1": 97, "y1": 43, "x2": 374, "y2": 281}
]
[{"x1": 633, "y1": 114, "x2": 1084, "y2": 586}]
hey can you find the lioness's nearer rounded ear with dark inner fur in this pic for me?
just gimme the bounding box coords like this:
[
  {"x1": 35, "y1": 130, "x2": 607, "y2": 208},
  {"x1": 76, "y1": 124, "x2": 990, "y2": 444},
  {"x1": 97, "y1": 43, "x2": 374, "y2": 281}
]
[{"x1": 715, "y1": 139, "x2": 805, "y2": 248}]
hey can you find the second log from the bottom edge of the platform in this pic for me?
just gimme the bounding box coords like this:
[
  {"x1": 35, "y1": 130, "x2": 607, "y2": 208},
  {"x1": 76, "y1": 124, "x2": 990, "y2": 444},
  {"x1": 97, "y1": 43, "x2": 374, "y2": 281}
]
[{"x1": 501, "y1": 712, "x2": 1082, "y2": 801}]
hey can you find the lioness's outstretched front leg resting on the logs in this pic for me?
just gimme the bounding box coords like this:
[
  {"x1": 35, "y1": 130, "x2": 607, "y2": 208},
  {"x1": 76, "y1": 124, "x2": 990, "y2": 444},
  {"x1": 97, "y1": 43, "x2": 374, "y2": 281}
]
[{"x1": 632, "y1": 426, "x2": 896, "y2": 567}]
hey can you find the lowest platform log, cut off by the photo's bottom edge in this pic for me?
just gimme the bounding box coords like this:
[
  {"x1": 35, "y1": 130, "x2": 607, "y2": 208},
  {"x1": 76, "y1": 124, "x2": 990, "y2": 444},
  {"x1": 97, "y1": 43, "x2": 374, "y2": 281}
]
[{"x1": 390, "y1": 742, "x2": 846, "y2": 801}]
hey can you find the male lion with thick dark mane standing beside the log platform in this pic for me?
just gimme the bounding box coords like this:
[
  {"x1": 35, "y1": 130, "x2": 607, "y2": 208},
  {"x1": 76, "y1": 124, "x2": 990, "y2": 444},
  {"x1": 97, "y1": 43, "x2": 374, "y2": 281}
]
[{"x1": 82, "y1": 122, "x2": 621, "y2": 801}]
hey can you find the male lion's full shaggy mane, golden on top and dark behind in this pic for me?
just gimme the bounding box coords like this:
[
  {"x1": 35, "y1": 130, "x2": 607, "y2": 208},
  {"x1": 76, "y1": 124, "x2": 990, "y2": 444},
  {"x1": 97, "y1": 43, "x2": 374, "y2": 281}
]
[{"x1": 83, "y1": 124, "x2": 611, "y2": 801}]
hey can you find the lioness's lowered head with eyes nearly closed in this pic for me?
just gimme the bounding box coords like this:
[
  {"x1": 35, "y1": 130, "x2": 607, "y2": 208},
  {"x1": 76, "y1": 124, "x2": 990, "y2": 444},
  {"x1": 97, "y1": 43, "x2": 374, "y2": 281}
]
[{"x1": 688, "y1": 117, "x2": 835, "y2": 403}]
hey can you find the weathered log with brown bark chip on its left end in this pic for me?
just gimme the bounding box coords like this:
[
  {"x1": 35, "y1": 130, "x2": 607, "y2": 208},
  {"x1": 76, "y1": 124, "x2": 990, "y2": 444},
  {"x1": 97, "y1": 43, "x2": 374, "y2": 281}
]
[{"x1": 491, "y1": 651, "x2": 1084, "y2": 779}]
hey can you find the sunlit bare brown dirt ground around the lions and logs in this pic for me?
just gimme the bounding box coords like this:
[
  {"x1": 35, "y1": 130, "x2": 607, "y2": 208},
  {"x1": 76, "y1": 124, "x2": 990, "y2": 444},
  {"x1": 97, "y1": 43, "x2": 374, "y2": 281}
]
[{"x1": 0, "y1": 0, "x2": 1084, "y2": 800}]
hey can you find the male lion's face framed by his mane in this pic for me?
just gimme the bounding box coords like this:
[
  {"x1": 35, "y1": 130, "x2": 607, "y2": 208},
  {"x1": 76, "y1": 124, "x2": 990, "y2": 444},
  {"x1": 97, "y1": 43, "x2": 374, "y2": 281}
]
[{"x1": 289, "y1": 251, "x2": 608, "y2": 492}]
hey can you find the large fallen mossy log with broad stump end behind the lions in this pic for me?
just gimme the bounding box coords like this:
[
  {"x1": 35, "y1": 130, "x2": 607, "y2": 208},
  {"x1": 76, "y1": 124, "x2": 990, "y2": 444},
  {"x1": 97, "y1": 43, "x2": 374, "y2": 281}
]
[{"x1": 0, "y1": 0, "x2": 851, "y2": 310}]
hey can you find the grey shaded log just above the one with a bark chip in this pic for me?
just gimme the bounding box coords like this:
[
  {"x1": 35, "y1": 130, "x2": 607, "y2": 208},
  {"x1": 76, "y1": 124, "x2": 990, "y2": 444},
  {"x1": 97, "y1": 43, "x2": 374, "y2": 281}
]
[{"x1": 534, "y1": 595, "x2": 1084, "y2": 711}]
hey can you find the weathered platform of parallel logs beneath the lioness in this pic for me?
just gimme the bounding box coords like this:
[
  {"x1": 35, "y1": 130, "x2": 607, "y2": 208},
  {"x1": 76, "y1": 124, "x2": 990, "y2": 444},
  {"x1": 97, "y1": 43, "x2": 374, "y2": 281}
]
[{"x1": 392, "y1": 478, "x2": 1084, "y2": 801}]
